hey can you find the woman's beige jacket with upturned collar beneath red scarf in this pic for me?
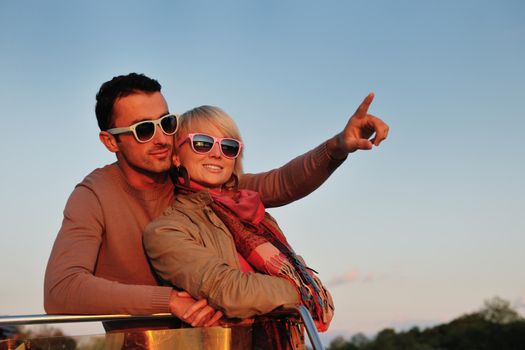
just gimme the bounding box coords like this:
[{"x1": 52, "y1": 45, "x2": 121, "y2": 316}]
[{"x1": 143, "y1": 191, "x2": 300, "y2": 318}]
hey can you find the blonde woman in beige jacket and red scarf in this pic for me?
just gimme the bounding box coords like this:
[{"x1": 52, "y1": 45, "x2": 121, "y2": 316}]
[{"x1": 143, "y1": 106, "x2": 333, "y2": 348}]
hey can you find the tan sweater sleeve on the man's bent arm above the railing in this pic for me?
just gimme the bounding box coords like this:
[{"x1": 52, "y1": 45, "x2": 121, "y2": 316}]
[{"x1": 44, "y1": 186, "x2": 172, "y2": 315}]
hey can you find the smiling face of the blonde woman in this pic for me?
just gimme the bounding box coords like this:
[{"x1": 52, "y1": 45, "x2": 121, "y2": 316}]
[{"x1": 173, "y1": 124, "x2": 235, "y2": 188}]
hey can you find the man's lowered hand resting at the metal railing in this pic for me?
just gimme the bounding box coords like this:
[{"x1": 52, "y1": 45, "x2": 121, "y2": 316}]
[{"x1": 170, "y1": 290, "x2": 222, "y2": 327}]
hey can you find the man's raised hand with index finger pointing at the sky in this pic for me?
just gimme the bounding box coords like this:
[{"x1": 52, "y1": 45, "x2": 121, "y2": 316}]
[{"x1": 327, "y1": 92, "x2": 388, "y2": 160}]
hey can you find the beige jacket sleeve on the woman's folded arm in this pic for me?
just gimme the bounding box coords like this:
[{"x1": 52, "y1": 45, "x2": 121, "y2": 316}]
[{"x1": 143, "y1": 215, "x2": 299, "y2": 318}]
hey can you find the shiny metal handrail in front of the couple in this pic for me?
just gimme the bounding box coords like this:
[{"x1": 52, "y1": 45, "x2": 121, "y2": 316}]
[{"x1": 0, "y1": 305, "x2": 324, "y2": 350}]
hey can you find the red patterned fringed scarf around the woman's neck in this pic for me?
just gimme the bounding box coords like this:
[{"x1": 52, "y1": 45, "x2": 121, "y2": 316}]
[{"x1": 176, "y1": 182, "x2": 334, "y2": 331}]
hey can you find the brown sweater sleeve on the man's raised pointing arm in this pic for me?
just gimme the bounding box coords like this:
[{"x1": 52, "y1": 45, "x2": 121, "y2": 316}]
[{"x1": 239, "y1": 142, "x2": 344, "y2": 208}]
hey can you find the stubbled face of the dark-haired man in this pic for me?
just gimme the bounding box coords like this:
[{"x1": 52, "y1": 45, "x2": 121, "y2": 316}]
[{"x1": 113, "y1": 92, "x2": 173, "y2": 175}]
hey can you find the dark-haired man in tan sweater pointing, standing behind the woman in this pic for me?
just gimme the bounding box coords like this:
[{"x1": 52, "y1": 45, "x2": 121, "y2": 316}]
[{"x1": 44, "y1": 73, "x2": 388, "y2": 326}]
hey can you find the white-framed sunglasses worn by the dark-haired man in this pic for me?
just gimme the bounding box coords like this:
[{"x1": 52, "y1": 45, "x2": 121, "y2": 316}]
[{"x1": 107, "y1": 114, "x2": 179, "y2": 143}]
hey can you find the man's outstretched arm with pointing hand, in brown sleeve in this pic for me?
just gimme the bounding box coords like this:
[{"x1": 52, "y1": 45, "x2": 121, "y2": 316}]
[{"x1": 239, "y1": 93, "x2": 388, "y2": 208}]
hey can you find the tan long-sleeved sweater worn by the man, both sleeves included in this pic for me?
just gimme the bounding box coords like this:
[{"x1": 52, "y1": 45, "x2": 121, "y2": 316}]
[{"x1": 44, "y1": 144, "x2": 342, "y2": 315}]
